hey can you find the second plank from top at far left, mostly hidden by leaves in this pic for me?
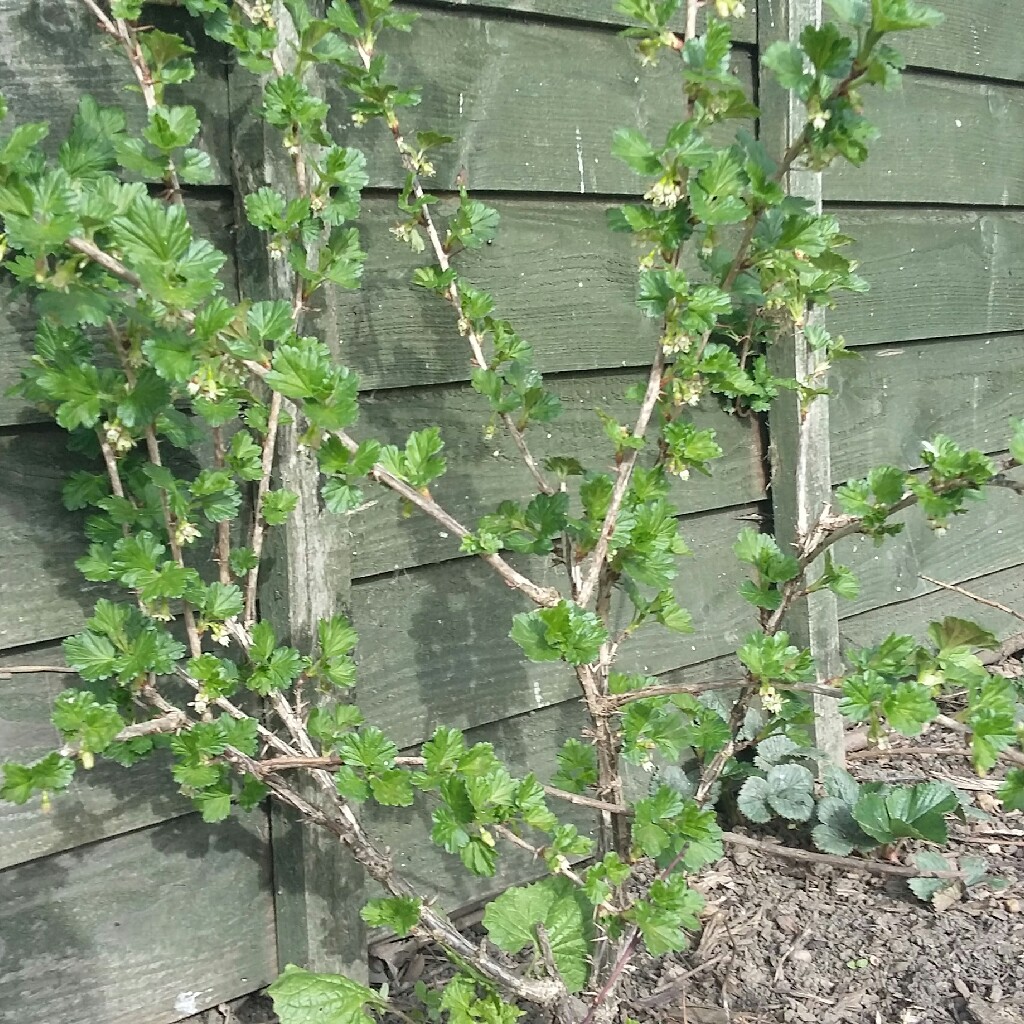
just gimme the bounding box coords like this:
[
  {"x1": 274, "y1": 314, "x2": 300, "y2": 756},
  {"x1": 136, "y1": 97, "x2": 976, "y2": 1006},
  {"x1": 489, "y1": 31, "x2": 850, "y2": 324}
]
[{"x1": 0, "y1": 191, "x2": 238, "y2": 426}]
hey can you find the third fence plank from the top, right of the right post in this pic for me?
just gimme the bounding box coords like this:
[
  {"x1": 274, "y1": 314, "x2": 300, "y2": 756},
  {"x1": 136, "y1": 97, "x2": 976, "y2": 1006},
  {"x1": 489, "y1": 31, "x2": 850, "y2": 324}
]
[{"x1": 827, "y1": 207, "x2": 1024, "y2": 345}]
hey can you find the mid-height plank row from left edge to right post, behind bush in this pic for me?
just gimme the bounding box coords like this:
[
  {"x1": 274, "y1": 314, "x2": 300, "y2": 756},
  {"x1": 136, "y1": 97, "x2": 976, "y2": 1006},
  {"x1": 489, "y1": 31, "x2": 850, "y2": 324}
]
[{"x1": 0, "y1": 407, "x2": 765, "y2": 638}]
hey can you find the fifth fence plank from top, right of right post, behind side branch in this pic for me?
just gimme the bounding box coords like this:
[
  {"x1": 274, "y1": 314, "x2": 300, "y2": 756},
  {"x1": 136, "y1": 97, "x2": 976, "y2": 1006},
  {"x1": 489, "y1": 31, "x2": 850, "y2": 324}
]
[{"x1": 836, "y1": 487, "x2": 1024, "y2": 618}]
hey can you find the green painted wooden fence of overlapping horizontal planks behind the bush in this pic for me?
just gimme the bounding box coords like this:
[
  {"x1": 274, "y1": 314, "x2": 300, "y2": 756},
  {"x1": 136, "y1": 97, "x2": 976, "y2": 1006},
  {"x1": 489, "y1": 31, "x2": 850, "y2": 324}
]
[{"x1": 0, "y1": 0, "x2": 1024, "y2": 1024}]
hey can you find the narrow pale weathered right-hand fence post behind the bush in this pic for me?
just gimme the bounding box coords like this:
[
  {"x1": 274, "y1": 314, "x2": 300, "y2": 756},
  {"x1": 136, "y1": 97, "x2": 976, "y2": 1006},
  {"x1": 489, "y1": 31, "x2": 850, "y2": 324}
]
[{"x1": 758, "y1": 0, "x2": 844, "y2": 764}]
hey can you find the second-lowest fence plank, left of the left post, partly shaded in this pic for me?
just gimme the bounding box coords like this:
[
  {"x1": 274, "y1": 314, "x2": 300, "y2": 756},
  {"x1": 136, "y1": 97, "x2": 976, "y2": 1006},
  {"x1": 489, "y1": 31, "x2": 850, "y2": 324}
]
[{"x1": 0, "y1": 644, "x2": 193, "y2": 868}]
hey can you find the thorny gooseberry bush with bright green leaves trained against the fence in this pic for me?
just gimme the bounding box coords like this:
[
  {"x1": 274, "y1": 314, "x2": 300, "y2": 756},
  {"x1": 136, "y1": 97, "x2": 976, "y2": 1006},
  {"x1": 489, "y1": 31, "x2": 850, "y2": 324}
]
[{"x1": 0, "y1": 0, "x2": 1024, "y2": 1024}]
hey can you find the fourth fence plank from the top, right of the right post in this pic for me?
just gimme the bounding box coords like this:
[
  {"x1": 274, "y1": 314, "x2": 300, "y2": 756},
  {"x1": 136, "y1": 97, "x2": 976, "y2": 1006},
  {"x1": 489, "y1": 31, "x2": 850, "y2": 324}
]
[{"x1": 830, "y1": 334, "x2": 1024, "y2": 483}]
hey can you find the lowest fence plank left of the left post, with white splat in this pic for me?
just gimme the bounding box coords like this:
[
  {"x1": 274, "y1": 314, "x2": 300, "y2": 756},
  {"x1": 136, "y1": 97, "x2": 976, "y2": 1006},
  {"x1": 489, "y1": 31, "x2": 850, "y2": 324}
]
[{"x1": 0, "y1": 813, "x2": 278, "y2": 1024}]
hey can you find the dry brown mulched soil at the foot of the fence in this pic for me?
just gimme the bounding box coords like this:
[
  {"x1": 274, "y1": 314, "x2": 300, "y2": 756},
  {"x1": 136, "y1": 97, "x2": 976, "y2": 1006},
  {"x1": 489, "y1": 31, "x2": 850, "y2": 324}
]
[{"x1": 188, "y1": 662, "x2": 1024, "y2": 1024}]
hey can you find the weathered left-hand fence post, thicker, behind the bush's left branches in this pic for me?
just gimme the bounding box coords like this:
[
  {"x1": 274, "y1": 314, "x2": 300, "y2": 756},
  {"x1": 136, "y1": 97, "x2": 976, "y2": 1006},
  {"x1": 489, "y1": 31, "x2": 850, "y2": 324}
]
[{"x1": 229, "y1": 2, "x2": 367, "y2": 980}]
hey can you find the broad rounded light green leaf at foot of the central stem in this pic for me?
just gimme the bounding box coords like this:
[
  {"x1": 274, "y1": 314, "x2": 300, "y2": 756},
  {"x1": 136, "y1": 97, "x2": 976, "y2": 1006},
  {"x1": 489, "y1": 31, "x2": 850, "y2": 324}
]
[{"x1": 483, "y1": 877, "x2": 592, "y2": 992}]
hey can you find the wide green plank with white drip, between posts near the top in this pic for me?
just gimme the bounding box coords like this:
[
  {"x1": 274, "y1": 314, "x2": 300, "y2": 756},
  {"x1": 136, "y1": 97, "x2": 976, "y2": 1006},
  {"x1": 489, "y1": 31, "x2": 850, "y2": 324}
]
[{"x1": 331, "y1": 10, "x2": 751, "y2": 195}]
